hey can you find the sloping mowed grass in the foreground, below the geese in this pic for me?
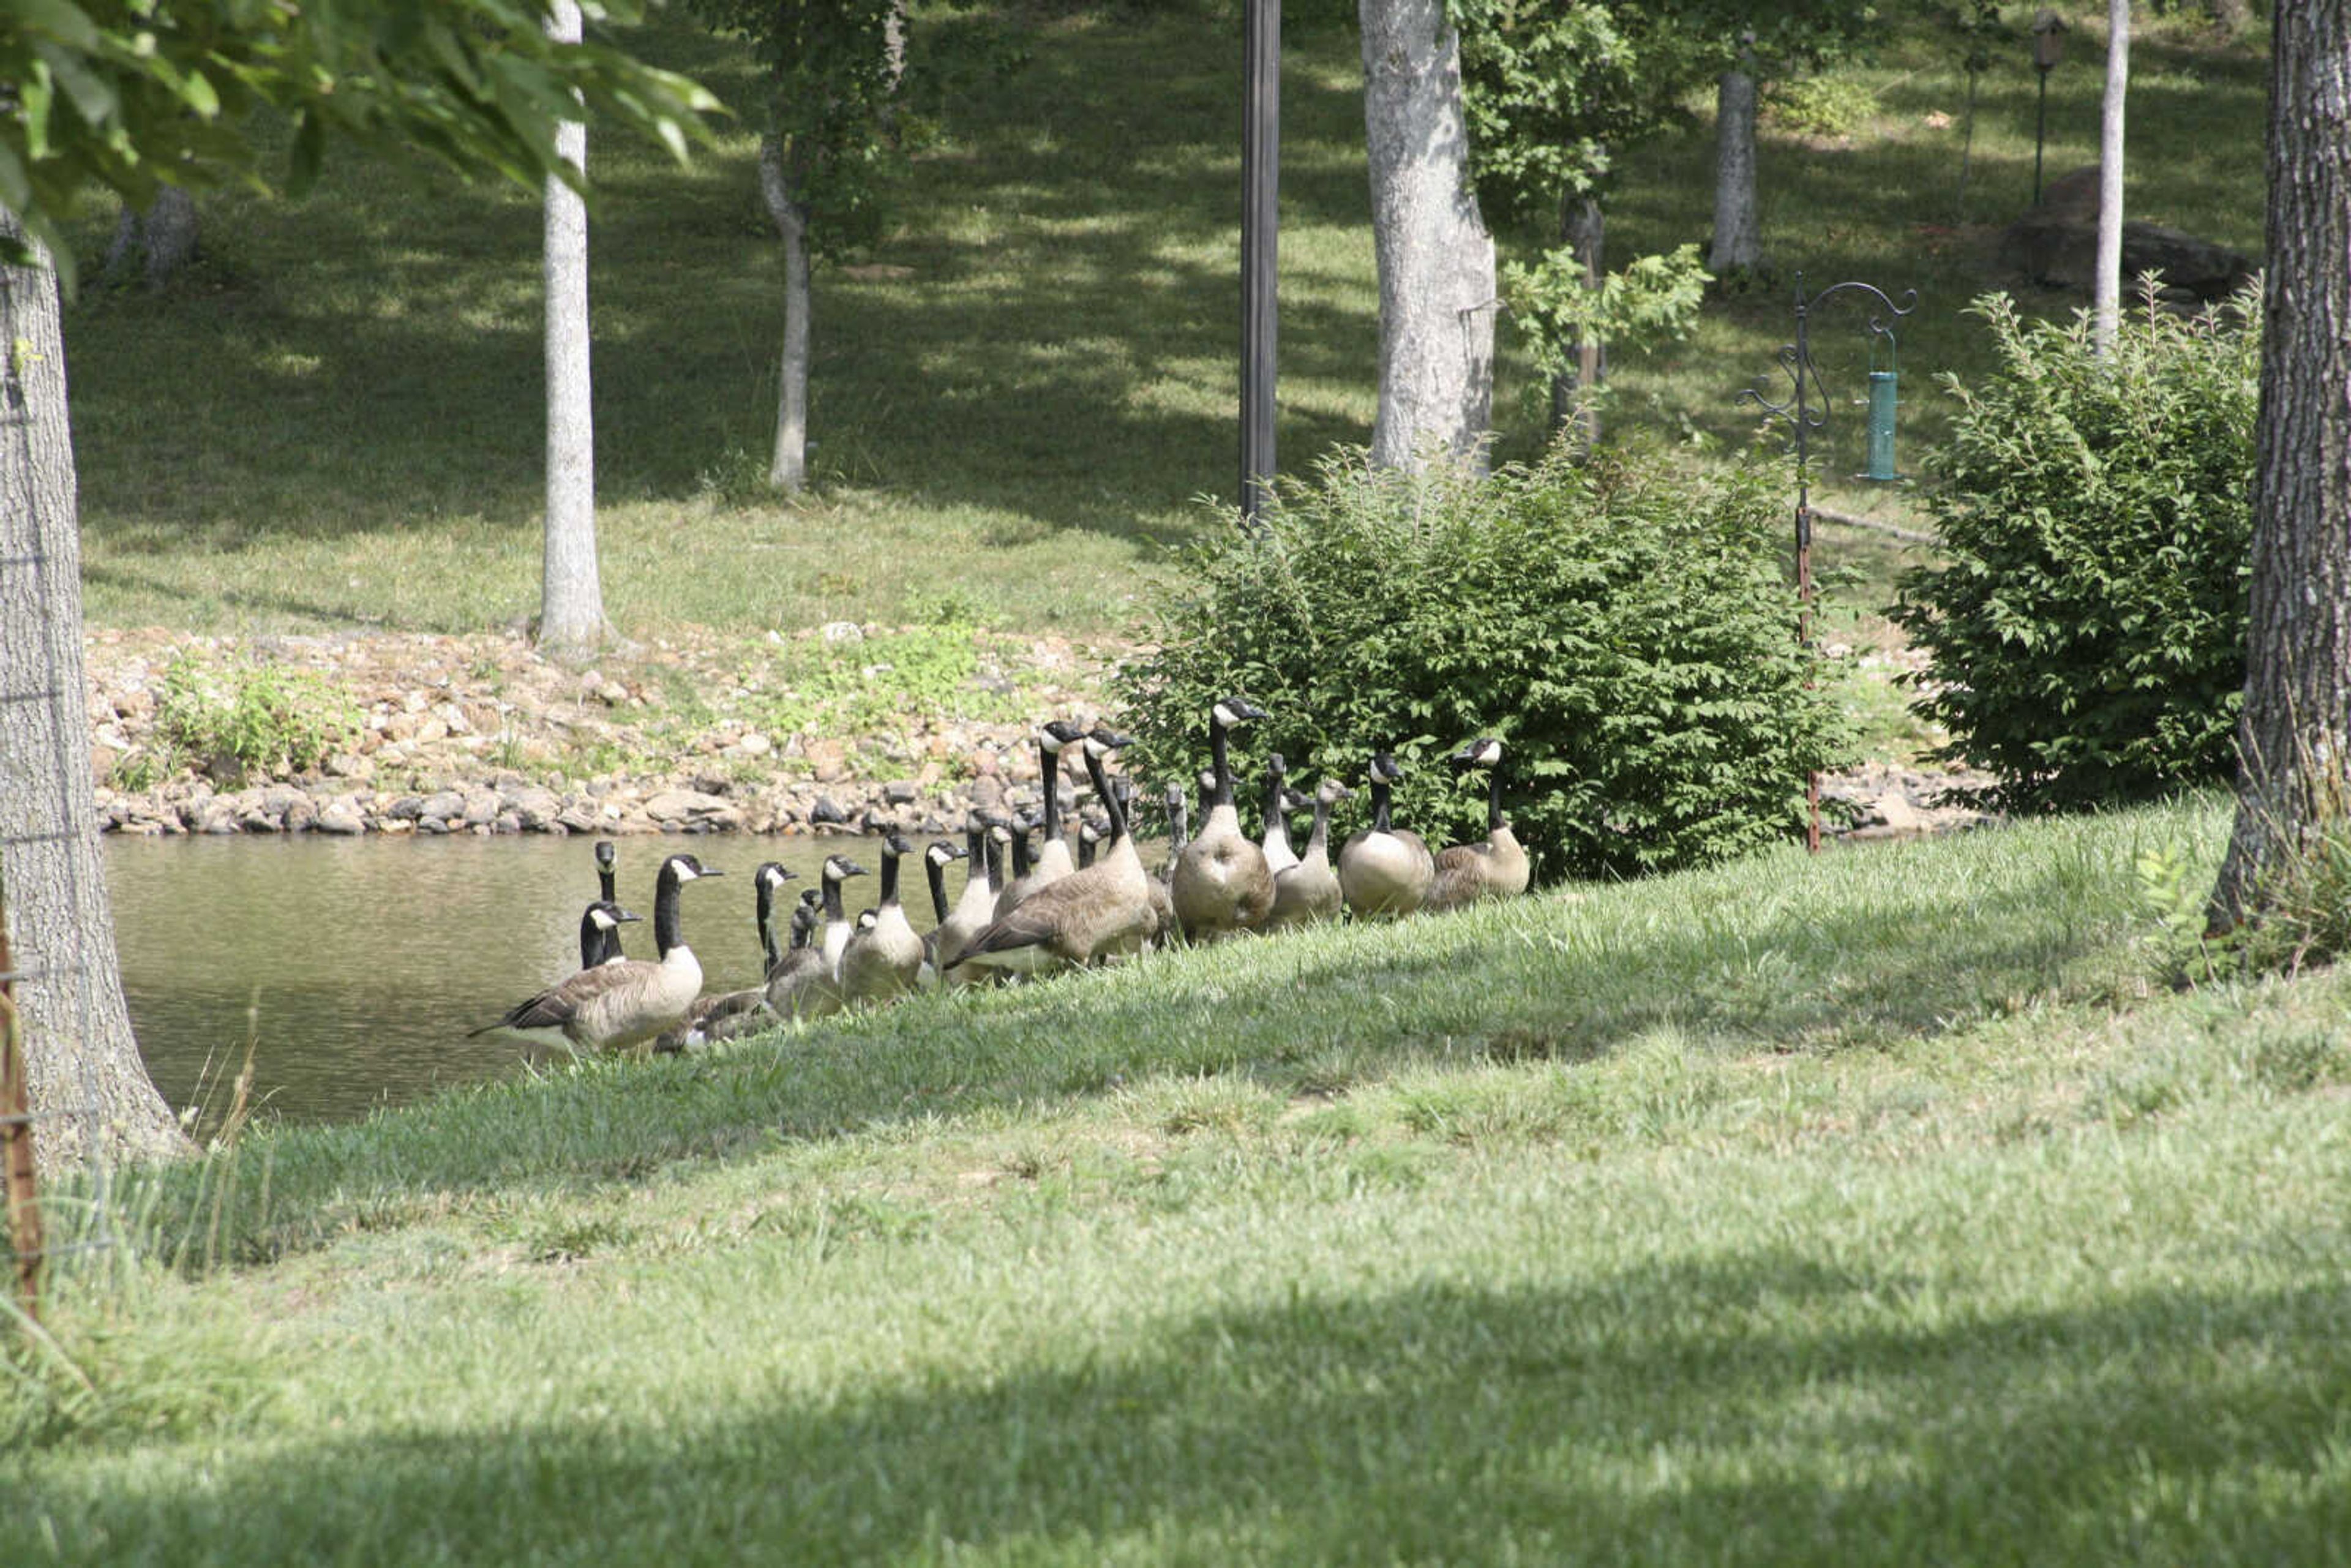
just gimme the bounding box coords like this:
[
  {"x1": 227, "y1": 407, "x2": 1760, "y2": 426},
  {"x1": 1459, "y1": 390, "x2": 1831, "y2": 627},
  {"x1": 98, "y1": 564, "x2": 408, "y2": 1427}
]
[{"x1": 0, "y1": 799, "x2": 2351, "y2": 1566}]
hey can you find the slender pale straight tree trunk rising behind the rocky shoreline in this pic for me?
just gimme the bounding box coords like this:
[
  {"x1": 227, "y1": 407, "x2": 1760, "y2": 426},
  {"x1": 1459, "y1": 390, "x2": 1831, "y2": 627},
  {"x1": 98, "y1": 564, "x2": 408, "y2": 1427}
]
[{"x1": 538, "y1": 0, "x2": 611, "y2": 658}]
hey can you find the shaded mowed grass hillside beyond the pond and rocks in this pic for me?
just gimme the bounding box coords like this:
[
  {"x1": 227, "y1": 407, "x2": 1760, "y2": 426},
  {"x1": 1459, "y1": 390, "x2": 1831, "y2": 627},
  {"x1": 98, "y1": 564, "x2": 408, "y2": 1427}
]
[{"x1": 68, "y1": 5, "x2": 2267, "y2": 635}]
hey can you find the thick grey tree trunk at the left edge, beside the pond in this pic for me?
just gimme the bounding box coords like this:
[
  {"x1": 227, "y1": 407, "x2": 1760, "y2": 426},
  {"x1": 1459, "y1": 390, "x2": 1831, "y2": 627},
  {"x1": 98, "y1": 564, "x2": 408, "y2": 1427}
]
[{"x1": 0, "y1": 209, "x2": 188, "y2": 1171}]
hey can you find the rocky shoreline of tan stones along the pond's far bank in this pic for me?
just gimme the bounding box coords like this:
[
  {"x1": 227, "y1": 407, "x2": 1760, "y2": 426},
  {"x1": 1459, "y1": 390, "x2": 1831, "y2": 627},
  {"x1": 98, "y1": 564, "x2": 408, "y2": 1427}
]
[{"x1": 73, "y1": 623, "x2": 1984, "y2": 839}]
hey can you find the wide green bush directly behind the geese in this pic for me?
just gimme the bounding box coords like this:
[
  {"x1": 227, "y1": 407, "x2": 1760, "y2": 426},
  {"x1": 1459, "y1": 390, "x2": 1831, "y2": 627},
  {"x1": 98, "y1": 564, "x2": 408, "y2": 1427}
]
[{"x1": 1117, "y1": 451, "x2": 1850, "y2": 877}]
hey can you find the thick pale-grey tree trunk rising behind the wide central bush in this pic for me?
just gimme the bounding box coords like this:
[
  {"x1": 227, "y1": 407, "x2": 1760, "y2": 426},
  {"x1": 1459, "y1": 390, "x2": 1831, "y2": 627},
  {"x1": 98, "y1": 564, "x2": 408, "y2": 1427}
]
[{"x1": 1359, "y1": 0, "x2": 1498, "y2": 468}]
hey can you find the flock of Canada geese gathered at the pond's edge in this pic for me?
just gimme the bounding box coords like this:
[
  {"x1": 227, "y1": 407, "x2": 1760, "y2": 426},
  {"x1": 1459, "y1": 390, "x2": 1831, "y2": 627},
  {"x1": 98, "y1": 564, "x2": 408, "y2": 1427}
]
[{"x1": 473, "y1": 696, "x2": 1528, "y2": 1051}]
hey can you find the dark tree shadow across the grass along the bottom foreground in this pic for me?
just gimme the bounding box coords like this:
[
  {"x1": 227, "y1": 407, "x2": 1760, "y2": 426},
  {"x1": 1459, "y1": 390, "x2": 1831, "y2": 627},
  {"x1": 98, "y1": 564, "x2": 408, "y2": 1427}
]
[{"x1": 23, "y1": 1260, "x2": 2351, "y2": 1568}]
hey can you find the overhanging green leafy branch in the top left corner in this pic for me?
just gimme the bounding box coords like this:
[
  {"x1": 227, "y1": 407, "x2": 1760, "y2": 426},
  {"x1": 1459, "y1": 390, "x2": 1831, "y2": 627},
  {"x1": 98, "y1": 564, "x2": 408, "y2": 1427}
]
[{"x1": 0, "y1": 0, "x2": 717, "y2": 288}]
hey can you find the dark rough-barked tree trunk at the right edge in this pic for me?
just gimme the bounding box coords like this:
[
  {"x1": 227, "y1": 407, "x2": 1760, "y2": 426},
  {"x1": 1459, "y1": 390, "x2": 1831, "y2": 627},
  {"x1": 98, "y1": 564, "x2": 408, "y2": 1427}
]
[{"x1": 2212, "y1": 0, "x2": 2351, "y2": 929}]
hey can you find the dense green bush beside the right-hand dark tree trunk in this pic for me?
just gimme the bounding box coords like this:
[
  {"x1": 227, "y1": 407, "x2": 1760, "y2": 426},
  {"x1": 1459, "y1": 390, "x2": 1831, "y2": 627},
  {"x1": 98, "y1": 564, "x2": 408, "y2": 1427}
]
[{"x1": 1890, "y1": 294, "x2": 2262, "y2": 809}]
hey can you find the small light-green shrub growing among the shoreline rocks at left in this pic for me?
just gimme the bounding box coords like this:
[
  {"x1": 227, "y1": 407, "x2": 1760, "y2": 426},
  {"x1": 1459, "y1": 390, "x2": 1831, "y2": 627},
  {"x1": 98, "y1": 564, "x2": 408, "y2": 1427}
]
[{"x1": 155, "y1": 653, "x2": 360, "y2": 778}]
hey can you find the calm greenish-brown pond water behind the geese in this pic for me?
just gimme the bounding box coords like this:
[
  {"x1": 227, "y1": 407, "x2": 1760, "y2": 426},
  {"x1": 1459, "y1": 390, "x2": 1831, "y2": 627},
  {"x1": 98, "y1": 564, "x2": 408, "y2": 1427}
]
[{"x1": 106, "y1": 835, "x2": 964, "y2": 1121}]
